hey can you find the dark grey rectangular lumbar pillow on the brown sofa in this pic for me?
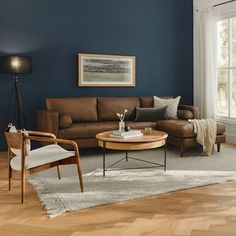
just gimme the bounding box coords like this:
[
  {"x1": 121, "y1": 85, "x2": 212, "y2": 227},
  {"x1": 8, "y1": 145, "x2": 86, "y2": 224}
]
[{"x1": 135, "y1": 106, "x2": 167, "y2": 121}]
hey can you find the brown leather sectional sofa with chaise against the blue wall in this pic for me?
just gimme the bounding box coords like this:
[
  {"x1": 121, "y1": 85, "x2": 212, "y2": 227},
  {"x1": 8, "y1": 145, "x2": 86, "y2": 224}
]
[{"x1": 37, "y1": 96, "x2": 225, "y2": 156}]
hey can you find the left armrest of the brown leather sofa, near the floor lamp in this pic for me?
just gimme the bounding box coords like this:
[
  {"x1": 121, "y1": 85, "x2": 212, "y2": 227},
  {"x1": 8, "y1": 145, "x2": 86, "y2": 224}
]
[{"x1": 37, "y1": 110, "x2": 59, "y2": 137}]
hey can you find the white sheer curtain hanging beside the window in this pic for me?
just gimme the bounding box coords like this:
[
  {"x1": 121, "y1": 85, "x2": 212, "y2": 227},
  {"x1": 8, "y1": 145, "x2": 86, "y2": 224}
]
[{"x1": 194, "y1": 7, "x2": 217, "y2": 119}]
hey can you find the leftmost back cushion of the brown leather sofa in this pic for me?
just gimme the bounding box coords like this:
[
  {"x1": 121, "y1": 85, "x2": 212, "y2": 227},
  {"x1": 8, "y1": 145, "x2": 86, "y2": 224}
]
[{"x1": 46, "y1": 97, "x2": 98, "y2": 122}]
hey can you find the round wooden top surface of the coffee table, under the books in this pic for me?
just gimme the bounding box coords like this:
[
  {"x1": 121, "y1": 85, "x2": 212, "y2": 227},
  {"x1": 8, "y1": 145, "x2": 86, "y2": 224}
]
[{"x1": 96, "y1": 130, "x2": 168, "y2": 143}]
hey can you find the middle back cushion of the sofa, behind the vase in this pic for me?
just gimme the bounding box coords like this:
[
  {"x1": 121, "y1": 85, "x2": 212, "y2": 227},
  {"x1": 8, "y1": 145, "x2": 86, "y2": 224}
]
[{"x1": 97, "y1": 97, "x2": 140, "y2": 121}]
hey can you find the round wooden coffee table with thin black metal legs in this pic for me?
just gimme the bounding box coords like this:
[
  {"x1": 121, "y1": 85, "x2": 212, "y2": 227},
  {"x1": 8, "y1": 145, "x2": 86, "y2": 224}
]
[{"x1": 96, "y1": 130, "x2": 168, "y2": 176}]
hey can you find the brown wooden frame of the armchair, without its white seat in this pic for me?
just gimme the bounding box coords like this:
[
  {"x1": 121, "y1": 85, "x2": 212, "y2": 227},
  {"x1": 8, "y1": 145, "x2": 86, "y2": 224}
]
[{"x1": 5, "y1": 130, "x2": 84, "y2": 203}]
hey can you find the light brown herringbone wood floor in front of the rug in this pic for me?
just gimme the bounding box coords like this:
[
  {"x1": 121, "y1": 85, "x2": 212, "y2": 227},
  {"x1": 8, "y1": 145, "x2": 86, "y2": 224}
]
[{"x1": 0, "y1": 149, "x2": 236, "y2": 236}]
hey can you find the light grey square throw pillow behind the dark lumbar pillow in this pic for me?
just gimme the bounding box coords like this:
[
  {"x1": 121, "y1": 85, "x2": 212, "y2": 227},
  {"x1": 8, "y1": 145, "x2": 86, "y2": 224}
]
[{"x1": 153, "y1": 96, "x2": 181, "y2": 119}]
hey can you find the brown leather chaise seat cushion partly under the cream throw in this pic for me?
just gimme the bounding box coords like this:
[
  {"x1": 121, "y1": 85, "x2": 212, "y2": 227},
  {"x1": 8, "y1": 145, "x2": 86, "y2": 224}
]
[{"x1": 157, "y1": 120, "x2": 225, "y2": 138}]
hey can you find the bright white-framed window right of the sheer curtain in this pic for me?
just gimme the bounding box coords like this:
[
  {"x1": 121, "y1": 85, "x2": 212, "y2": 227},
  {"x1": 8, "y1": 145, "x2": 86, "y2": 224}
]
[{"x1": 216, "y1": 17, "x2": 236, "y2": 118}]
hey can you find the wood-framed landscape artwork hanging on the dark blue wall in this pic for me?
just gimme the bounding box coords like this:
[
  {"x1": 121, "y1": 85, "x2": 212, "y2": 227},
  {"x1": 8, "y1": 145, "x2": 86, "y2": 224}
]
[{"x1": 78, "y1": 53, "x2": 135, "y2": 87}]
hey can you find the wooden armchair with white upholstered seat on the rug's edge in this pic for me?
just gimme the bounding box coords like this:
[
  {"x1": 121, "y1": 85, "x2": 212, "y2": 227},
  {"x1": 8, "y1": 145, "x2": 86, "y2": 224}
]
[{"x1": 5, "y1": 130, "x2": 83, "y2": 203}]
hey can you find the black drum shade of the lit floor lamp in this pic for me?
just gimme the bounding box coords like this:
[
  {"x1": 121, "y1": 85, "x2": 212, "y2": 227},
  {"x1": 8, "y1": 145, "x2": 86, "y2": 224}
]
[{"x1": 0, "y1": 56, "x2": 32, "y2": 74}]
